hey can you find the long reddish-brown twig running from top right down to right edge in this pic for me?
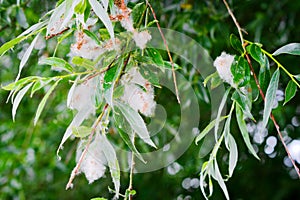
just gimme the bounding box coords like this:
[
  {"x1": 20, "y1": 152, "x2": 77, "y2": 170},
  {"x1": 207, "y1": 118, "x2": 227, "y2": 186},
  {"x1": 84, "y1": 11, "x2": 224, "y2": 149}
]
[{"x1": 223, "y1": 0, "x2": 300, "y2": 178}]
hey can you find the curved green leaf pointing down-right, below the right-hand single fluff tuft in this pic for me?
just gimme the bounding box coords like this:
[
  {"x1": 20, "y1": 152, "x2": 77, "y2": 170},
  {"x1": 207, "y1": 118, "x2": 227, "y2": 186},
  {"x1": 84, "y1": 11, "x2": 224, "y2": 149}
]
[{"x1": 236, "y1": 106, "x2": 259, "y2": 160}]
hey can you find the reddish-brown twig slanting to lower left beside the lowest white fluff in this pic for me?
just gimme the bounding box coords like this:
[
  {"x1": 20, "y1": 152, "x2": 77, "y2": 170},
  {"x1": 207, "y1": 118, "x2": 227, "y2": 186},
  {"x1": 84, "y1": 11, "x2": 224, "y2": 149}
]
[{"x1": 66, "y1": 104, "x2": 108, "y2": 190}]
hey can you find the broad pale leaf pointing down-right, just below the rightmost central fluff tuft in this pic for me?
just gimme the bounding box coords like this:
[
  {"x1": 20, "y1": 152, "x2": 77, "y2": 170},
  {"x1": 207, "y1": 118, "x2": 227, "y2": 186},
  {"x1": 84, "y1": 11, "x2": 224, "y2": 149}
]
[{"x1": 115, "y1": 101, "x2": 156, "y2": 148}]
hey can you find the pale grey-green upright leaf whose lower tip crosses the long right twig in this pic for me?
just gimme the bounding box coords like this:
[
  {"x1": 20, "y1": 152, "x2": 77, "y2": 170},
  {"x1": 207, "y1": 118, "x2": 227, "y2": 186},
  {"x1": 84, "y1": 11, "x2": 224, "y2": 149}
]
[{"x1": 261, "y1": 68, "x2": 280, "y2": 130}]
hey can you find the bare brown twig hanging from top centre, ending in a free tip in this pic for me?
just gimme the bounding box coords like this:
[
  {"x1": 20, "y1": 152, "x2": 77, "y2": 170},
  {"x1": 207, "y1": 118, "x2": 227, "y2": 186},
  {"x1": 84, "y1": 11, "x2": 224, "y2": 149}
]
[{"x1": 146, "y1": 0, "x2": 180, "y2": 104}]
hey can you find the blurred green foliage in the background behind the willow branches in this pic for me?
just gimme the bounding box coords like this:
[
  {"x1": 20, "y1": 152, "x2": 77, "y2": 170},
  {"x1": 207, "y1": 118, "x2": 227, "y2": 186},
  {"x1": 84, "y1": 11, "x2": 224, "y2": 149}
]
[{"x1": 0, "y1": 0, "x2": 300, "y2": 200}]
